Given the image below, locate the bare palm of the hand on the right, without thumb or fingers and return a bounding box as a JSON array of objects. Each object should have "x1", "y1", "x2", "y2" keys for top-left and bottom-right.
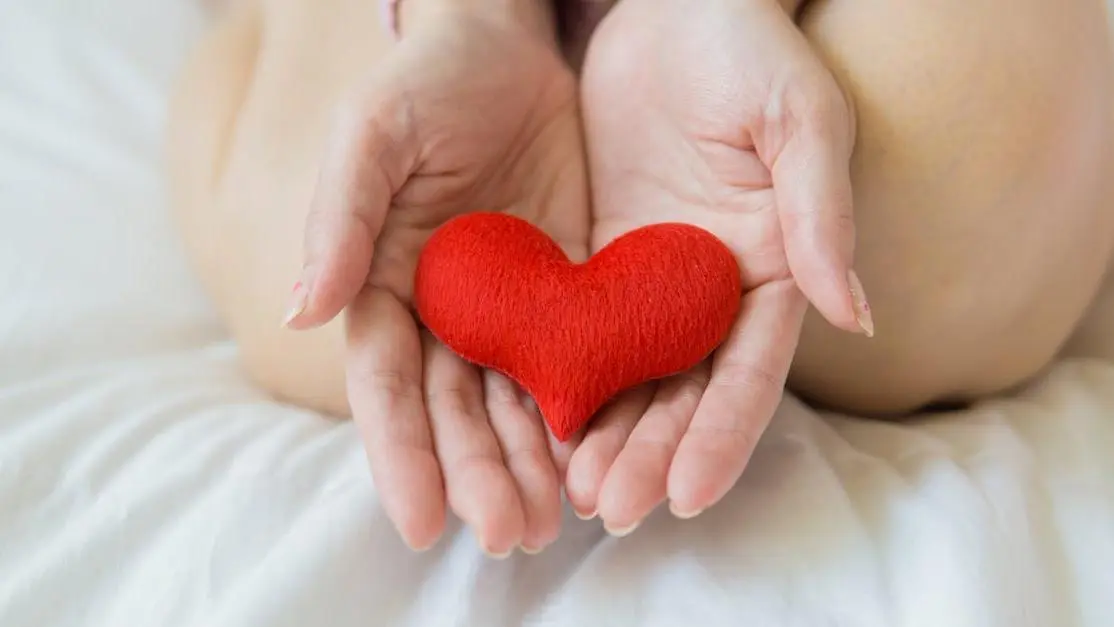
[{"x1": 584, "y1": 0, "x2": 789, "y2": 281}]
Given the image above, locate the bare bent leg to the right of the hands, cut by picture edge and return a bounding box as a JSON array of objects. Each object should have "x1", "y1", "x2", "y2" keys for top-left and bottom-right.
[{"x1": 790, "y1": 0, "x2": 1114, "y2": 412}]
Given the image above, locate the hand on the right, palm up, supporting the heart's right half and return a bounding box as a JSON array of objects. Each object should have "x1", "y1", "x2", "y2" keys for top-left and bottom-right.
[{"x1": 566, "y1": 0, "x2": 872, "y2": 535}]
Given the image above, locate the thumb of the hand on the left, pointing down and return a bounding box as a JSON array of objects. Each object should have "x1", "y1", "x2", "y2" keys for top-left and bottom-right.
[{"x1": 285, "y1": 79, "x2": 418, "y2": 329}]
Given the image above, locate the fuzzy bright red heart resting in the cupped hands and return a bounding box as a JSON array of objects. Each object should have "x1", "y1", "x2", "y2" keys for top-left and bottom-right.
[{"x1": 414, "y1": 213, "x2": 742, "y2": 441}]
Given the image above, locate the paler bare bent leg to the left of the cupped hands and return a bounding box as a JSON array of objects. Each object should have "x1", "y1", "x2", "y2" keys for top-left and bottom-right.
[{"x1": 169, "y1": 0, "x2": 390, "y2": 414}]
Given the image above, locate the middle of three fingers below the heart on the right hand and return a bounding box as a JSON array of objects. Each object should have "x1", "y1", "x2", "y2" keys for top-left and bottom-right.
[{"x1": 598, "y1": 362, "x2": 709, "y2": 537}]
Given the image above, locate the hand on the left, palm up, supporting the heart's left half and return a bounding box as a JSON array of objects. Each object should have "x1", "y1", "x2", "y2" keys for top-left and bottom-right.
[{"x1": 287, "y1": 0, "x2": 588, "y2": 556}]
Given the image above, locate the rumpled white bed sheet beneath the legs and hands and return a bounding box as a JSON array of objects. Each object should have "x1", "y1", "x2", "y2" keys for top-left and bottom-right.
[{"x1": 0, "y1": 0, "x2": 1114, "y2": 627}]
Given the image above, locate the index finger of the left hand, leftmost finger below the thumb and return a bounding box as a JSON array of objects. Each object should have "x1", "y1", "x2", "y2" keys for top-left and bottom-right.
[{"x1": 346, "y1": 287, "x2": 444, "y2": 550}]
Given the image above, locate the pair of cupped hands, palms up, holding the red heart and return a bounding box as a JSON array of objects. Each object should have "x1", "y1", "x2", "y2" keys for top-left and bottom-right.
[{"x1": 280, "y1": 0, "x2": 872, "y2": 556}]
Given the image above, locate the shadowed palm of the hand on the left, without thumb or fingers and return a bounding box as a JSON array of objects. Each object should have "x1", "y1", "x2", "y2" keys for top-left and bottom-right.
[{"x1": 369, "y1": 18, "x2": 587, "y2": 301}]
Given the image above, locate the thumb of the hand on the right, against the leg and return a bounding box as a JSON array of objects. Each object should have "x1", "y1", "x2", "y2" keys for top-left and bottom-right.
[{"x1": 771, "y1": 87, "x2": 873, "y2": 336}]
